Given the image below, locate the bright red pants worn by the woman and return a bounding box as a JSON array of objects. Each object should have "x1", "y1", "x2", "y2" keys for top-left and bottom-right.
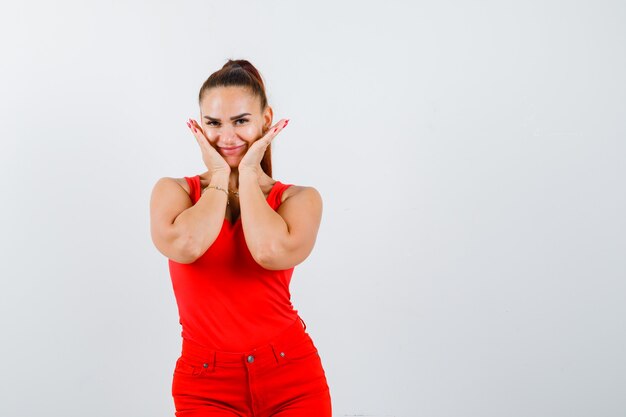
[{"x1": 172, "y1": 317, "x2": 332, "y2": 417}]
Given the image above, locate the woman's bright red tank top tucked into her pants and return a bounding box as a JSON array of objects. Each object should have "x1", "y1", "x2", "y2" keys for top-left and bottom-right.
[{"x1": 169, "y1": 175, "x2": 298, "y2": 352}]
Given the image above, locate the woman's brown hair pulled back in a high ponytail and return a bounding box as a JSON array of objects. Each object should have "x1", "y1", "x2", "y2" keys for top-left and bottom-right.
[{"x1": 198, "y1": 59, "x2": 272, "y2": 177}]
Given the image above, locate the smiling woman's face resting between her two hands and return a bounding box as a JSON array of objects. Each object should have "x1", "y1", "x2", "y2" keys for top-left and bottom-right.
[{"x1": 200, "y1": 86, "x2": 272, "y2": 168}]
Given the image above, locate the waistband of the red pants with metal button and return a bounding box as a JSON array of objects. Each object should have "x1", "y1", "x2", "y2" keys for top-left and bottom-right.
[{"x1": 181, "y1": 316, "x2": 313, "y2": 371}]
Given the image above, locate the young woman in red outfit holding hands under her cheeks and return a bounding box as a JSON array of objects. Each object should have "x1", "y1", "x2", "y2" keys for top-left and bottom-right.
[{"x1": 150, "y1": 60, "x2": 332, "y2": 417}]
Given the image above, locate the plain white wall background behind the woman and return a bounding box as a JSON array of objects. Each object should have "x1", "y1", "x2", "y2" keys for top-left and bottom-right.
[{"x1": 0, "y1": 0, "x2": 626, "y2": 417}]
